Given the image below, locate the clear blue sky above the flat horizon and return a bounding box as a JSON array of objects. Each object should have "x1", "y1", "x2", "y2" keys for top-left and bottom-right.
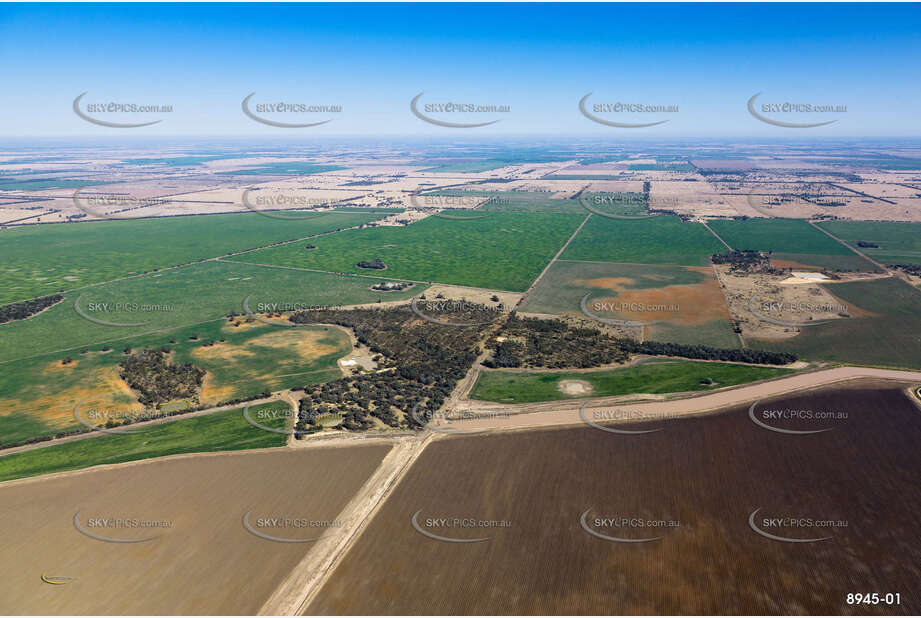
[{"x1": 0, "y1": 4, "x2": 921, "y2": 139}]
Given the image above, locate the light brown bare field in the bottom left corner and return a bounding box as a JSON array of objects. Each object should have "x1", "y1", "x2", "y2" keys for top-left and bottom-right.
[{"x1": 0, "y1": 443, "x2": 391, "y2": 615}]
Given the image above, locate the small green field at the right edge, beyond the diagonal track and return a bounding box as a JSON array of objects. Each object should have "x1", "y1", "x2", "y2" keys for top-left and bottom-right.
[{"x1": 819, "y1": 221, "x2": 921, "y2": 264}]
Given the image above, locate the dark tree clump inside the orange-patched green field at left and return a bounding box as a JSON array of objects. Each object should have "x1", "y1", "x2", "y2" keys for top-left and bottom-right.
[{"x1": 118, "y1": 348, "x2": 205, "y2": 406}]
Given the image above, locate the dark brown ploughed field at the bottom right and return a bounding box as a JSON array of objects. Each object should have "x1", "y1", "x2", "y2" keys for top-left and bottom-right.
[{"x1": 306, "y1": 383, "x2": 921, "y2": 615}]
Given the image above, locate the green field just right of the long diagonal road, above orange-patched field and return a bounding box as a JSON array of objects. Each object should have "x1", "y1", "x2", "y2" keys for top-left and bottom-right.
[{"x1": 561, "y1": 215, "x2": 725, "y2": 266}]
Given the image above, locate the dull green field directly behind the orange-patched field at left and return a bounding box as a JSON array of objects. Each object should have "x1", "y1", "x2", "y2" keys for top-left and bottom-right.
[{"x1": 0, "y1": 258, "x2": 426, "y2": 364}]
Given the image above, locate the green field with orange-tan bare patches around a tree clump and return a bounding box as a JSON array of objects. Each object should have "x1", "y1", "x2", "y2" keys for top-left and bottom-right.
[{"x1": 0, "y1": 319, "x2": 351, "y2": 442}]
